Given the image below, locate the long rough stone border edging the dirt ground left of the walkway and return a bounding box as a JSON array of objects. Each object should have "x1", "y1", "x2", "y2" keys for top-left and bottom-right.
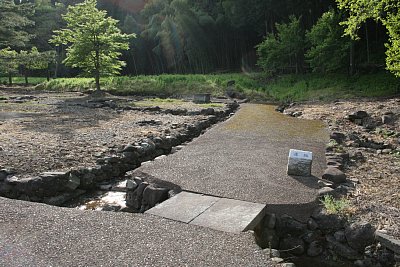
[{"x1": 0, "y1": 101, "x2": 239, "y2": 206}]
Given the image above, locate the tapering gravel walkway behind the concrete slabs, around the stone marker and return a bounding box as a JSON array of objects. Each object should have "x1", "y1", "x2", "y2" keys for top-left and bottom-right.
[{"x1": 137, "y1": 104, "x2": 329, "y2": 220}]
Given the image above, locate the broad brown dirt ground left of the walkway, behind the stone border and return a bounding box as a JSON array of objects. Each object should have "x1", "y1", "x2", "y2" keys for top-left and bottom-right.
[{"x1": 0, "y1": 88, "x2": 225, "y2": 176}]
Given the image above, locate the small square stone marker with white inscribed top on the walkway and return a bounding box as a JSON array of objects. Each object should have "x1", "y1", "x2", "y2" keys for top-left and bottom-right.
[{"x1": 287, "y1": 149, "x2": 312, "y2": 176}]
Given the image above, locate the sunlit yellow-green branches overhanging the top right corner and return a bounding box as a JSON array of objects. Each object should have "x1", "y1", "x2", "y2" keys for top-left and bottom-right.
[{"x1": 336, "y1": 0, "x2": 400, "y2": 77}]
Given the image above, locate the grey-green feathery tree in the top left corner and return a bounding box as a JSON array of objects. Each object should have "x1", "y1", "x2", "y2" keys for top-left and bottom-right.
[{"x1": 0, "y1": 0, "x2": 34, "y2": 48}]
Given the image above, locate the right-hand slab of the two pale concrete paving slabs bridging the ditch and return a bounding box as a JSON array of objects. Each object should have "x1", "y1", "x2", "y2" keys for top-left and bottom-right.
[{"x1": 190, "y1": 198, "x2": 265, "y2": 233}]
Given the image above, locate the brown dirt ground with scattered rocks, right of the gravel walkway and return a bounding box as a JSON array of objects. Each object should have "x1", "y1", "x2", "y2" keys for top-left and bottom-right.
[{"x1": 285, "y1": 98, "x2": 400, "y2": 239}]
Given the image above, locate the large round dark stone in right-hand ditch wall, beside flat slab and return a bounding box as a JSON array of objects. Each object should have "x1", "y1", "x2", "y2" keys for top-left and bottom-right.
[{"x1": 345, "y1": 222, "x2": 375, "y2": 252}]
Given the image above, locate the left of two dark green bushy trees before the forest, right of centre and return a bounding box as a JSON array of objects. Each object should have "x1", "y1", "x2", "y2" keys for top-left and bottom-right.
[{"x1": 257, "y1": 16, "x2": 305, "y2": 73}]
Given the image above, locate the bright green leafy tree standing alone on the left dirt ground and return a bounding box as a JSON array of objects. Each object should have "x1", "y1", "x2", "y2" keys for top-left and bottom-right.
[{"x1": 50, "y1": 0, "x2": 135, "y2": 91}]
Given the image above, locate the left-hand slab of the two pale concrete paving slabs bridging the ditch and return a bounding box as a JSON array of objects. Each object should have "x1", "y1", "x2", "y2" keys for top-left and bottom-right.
[{"x1": 145, "y1": 192, "x2": 220, "y2": 223}]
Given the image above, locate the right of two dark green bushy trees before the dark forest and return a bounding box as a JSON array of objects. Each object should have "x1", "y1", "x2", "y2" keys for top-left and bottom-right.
[{"x1": 306, "y1": 10, "x2": 351, "y2": 73}]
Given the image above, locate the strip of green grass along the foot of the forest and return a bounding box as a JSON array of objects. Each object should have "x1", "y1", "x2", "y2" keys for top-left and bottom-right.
[{"x1": 0, "y1": 72, "x2": 400, "y2": 102}]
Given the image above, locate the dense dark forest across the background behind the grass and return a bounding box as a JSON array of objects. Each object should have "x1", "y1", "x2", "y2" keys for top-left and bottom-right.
[{"x1": 0, "y1": 0, "x2": 397, "y2": 77}]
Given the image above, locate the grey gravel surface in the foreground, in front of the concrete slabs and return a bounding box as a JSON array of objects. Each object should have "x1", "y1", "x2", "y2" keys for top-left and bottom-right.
[{"x1": 0, "y1": 198, "x2": 273, "y2": 267}]
